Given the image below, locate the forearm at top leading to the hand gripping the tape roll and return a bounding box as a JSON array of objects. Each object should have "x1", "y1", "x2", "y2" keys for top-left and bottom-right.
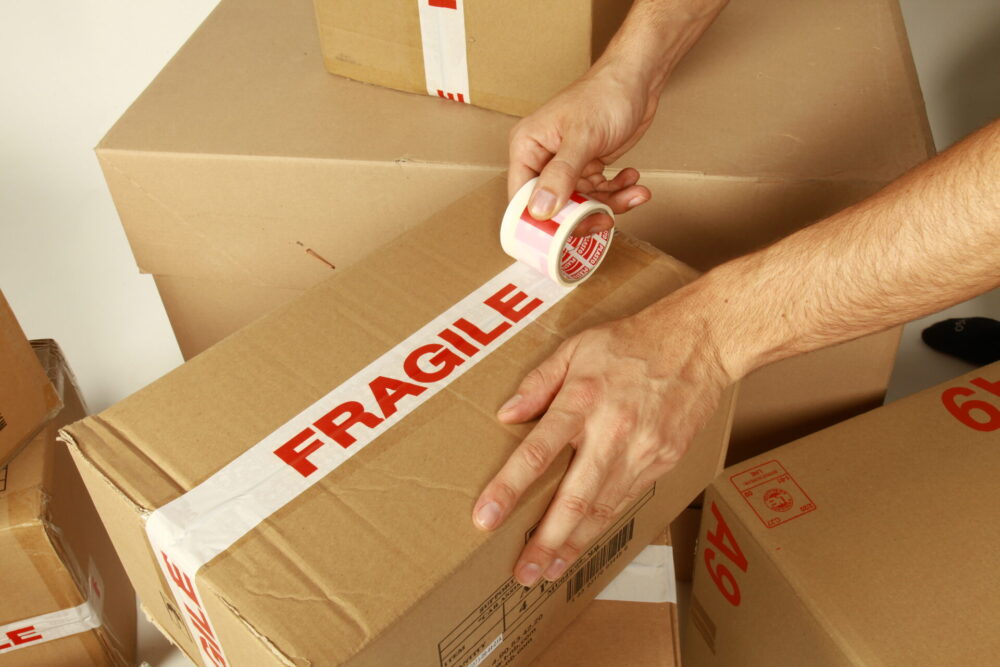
[{"x1": 594, "y1": 0, "x2": 728, "y2": 98}]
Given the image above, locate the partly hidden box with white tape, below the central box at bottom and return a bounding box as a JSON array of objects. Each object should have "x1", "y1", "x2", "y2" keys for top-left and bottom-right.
[{"x1": 531, "y1": 533, "x2": 681, "y2": 667}]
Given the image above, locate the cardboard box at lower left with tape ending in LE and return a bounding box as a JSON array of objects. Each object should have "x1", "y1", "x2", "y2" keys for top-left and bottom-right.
[{"x1": 0, "y1": 340, "x2": 135, "y2": 667}]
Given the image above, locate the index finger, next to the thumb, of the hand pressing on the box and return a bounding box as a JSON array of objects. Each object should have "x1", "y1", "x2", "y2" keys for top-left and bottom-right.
[{"x1": 472, "y1": 408, "x2": 583, "y2": 530}]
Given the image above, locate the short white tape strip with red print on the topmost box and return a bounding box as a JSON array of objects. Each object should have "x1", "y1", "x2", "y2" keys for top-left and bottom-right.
[{"x1": 417, "y1": 0, "x2": 471, "y2": 104}]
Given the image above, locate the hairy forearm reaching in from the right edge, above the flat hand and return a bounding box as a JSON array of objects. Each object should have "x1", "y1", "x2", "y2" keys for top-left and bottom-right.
[{"x1": 688, "y1": 121, "x2": 1000, "y2": 378}]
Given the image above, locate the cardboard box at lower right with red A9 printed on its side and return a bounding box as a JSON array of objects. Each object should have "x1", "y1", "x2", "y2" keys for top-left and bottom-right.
[{"x1": 684, "y1": 364, "x2": 1000, "y2": 667}]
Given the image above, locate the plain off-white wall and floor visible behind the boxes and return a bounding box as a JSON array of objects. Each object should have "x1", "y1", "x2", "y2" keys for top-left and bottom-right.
[{"x1": 0, "y1": 0, "x2": 1000, "y2": 665}]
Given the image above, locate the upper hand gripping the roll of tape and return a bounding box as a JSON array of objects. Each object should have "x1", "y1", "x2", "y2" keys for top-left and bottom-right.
[{"x1": 507, "y1": 64, "x2": 658, "y2": 235}]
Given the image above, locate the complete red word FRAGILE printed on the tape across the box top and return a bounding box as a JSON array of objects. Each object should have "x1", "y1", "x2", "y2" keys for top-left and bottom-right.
[{"x1": 276, "y1": 284, "x2": 542, "y2": 474}]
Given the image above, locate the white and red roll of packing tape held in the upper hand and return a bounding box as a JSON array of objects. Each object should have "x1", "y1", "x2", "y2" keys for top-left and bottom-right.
[{"x1": 500, "y1": 178, "x2": 615, "y2": 287}]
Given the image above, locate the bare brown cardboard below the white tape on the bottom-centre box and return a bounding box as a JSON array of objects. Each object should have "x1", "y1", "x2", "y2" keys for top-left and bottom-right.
[{"x1": 531, "y1": 533, "x2": 681, "y2": 667}]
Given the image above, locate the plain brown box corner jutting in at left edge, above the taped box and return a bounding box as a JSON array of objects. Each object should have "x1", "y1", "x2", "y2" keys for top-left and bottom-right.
[{"x1": 0, "y1": 292, "x2": 62, "y2": 466}]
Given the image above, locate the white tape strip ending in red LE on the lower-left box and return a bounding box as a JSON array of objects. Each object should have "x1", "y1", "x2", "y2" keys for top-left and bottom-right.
[{"x1": 0, "y1": 563, "x2": 104, "y2": 656}]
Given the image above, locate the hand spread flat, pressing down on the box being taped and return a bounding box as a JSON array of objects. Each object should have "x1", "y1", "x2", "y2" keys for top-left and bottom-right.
[{"x1": 473, "y1": 290, "x2": 732, "y2": 586}]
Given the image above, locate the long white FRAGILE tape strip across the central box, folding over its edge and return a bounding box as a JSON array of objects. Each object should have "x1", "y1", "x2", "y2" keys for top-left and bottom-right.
[{"x1": 146, "y1": 262, "x2": 572, "y2": 666}]
